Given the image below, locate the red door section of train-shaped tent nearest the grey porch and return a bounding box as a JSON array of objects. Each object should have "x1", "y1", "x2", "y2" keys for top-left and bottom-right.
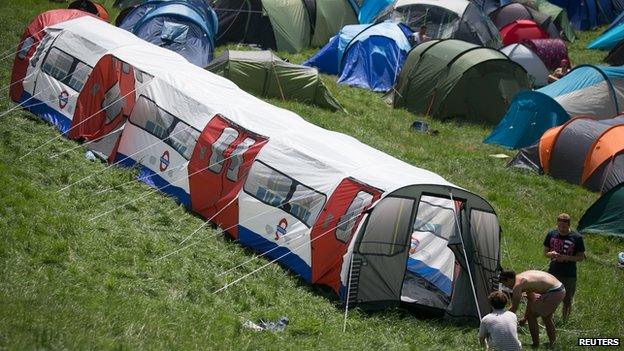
[{"x1": 310, "y1": 178, "x2": 381, "y2": 291}]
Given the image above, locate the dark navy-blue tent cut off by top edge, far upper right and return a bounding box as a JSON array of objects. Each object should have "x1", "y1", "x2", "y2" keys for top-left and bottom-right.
[{"x1": 549, "y1": 0, "x2": 621, "y2": 30}]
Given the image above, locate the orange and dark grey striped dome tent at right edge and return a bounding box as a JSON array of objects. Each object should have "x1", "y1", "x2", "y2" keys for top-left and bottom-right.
[{"x1": 510, "y1": 116, "x2": 624, "y2": 192}]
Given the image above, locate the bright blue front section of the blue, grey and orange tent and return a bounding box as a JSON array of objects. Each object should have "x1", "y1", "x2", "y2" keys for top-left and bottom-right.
[{"x1": 483, "y1": 91, "x2": 570, "y2": 149}]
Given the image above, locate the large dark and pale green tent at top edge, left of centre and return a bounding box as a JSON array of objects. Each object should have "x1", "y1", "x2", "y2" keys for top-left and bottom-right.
[{"x1": 213, "y1": 0, "x2": 357, "y2": 53}]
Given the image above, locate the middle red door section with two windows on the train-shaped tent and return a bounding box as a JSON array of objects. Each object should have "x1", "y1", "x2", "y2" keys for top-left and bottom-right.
[{"x1": 189, "y1": 115, "x2": 267, "y2": 237}]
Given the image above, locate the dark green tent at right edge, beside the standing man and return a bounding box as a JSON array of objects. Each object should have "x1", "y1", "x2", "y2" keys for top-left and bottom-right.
[{"x1": 578, "y1": 183, "x2": 624, "y2": 237}]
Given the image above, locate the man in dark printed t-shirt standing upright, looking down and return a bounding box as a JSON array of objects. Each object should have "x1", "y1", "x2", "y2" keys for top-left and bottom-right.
[{"x1": 544, "y1": 213, "x2": 585, "y2": 321}]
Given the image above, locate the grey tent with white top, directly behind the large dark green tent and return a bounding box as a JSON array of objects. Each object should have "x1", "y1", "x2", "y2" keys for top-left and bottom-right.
[{"x1": 378, "y1": 0, "x2": 502, "y2": 49}]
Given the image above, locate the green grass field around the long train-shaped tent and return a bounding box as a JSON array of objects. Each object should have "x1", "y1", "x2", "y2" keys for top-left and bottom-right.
[{"x1": 0, "y1": 0, "x2": 624, "y2": 350}]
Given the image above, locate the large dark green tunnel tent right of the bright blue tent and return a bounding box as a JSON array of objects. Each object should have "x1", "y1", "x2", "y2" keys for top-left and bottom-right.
[{"x1": 390, "y1": 39, "x2": 530, "y2": 124}]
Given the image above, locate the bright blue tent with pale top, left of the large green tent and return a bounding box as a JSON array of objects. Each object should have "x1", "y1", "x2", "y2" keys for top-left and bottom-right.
[{"x1": 303, "y1": 22, "x2": 412, "y2": 91}]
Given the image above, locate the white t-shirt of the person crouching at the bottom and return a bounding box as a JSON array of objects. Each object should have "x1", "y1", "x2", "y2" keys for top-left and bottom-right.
[{"x1": 479, "y1": 310, "x2": 522, "y2": 351}]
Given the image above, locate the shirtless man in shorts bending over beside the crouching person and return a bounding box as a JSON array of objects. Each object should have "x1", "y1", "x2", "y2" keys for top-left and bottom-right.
[{"x1": 499, "y1": 271, "x2": 565, "y2": 347}]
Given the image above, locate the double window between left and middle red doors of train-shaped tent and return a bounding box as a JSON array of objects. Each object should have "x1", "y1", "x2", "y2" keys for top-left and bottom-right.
[{"x1": 130, "y1": 95, "x2": 200, "y2": 160}]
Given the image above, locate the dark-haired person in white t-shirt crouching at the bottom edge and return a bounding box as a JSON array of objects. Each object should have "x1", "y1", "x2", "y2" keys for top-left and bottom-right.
[{"x1": 479, "y1": 291, "x2": 522, "y2": 351}]
